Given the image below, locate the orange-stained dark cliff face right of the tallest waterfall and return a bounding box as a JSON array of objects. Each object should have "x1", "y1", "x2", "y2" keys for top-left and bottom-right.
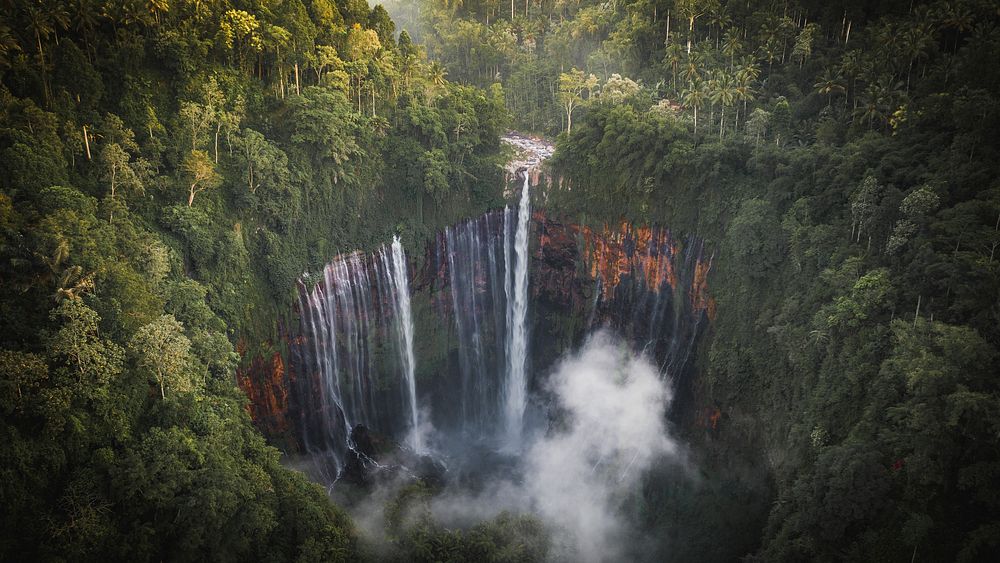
[{"x1": 531, "y1": 213, "x2": 715, "y2": 391}]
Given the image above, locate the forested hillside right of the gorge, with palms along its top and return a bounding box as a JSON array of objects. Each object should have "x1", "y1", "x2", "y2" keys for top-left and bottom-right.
[{"x1": 410, "y1": 0, "x2": 1000, "y2": 561}]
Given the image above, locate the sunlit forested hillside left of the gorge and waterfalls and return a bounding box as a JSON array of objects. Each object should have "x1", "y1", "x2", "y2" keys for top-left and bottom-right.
[{"x1": 0, "y1": 0, "x2": 506, "y2": 561}]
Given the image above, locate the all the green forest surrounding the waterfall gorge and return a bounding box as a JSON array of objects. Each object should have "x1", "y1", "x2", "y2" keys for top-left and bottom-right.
[{"x1": 0, "y1": 0, "x2": 1000, "y2": 561}]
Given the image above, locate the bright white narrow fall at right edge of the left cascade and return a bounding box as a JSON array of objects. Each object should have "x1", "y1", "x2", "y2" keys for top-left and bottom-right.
[{"x1": 382, "y1": 236, "x2": 423, "y2": 452}]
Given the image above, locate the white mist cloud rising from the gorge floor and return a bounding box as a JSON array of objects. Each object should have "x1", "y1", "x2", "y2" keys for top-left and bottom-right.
[{"x1": 414, "y1": 331, "x2": 678, "y2": 561}]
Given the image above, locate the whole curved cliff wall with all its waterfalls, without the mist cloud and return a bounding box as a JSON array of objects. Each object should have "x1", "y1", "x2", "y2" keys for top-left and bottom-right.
[{"x1": 278, "y1": 173, "x2": 714, "y2": 483}]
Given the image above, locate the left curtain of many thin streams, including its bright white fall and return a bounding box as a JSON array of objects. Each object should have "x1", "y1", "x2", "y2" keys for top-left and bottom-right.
[{"x1": 299, "y1": 237, "x2": 423, "y2": 481}]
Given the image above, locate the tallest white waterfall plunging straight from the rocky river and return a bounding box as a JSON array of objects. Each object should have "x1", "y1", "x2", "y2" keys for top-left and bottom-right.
[{"x1": 504, "y1": 171, "x2": 531, "y2": 446}]
